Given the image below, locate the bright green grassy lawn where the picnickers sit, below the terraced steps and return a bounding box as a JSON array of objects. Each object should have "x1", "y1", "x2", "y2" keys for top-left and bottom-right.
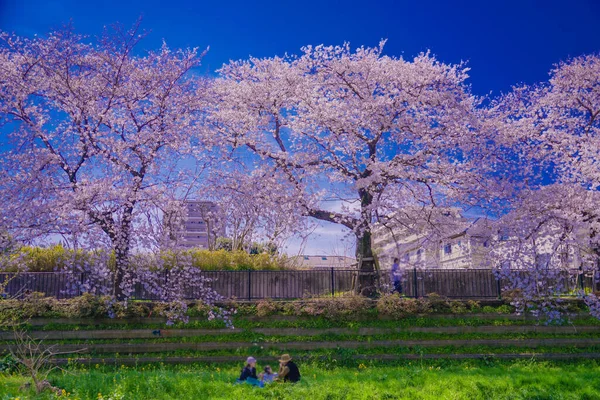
[{"x1": 0, "y1": 360, "x2": 600, "y2": 400}]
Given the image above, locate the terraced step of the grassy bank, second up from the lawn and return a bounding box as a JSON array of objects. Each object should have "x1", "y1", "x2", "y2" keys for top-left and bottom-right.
[{"x1": 0, "y1": 338, "x2": 600, "y2": 354}]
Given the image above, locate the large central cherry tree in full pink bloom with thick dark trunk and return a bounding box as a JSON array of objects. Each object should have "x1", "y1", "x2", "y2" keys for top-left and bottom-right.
[{"x1": 210, "y1": 42, "x2": 478, "y2": 292}]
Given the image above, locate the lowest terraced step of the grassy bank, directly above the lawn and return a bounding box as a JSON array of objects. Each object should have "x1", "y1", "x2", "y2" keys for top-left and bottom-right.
[{"x1": 51, "y1": 353, "x2": 600, "y2": 365}]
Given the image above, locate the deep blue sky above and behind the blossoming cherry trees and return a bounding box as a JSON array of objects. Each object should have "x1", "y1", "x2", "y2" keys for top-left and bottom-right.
[{"x1": 0, "y1": 0, "x2": 600, "y2": 254}]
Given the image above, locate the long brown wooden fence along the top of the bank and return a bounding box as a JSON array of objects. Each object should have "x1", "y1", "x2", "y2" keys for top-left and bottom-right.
[{"x1": 0, "y1": 268, "x2": 597, "y2": 300}]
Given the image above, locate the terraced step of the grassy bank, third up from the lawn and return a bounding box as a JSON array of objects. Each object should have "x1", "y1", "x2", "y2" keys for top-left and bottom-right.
[{"x1": 0, "y1": 325, "x2": 600, "y2": 340}]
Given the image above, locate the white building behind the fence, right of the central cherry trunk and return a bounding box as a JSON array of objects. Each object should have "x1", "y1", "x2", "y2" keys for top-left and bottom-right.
[{"x1": 373, "y1": 210, "x2": 590, "y2": 269}]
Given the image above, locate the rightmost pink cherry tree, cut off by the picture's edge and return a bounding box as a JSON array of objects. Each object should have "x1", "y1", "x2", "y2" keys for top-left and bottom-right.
[{"x1": 487, "y1": 55, "x2": 600, "y2": 316}]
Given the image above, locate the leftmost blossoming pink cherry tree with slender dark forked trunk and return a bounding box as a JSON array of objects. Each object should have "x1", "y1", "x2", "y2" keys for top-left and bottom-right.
[{"x1": 0, "y1": 26, "x2": 209, "y2": 300}]
